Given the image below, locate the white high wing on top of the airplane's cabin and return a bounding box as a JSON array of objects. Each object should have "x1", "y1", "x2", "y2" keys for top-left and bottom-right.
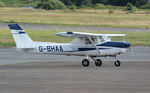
[{"x1": 55, "y1": 32, "x2": 126, "y2": 38}]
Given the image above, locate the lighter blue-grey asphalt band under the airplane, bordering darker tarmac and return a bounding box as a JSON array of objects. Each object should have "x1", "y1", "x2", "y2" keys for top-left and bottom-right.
[{"x1": 0, "y1": 46, "x2": 150, "y2": 65}]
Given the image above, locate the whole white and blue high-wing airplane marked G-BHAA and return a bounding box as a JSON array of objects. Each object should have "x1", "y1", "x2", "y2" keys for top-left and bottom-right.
[{"x1": 8, "y1": 23, "x2": 131, "y2": 67}]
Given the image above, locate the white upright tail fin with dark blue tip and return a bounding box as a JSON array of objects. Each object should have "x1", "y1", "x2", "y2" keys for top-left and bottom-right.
[{"x1": 8, "y1": 24, "x2": 33, "y2": 48}]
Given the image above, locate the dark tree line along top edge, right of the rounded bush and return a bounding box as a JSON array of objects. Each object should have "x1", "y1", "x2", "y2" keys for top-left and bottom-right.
[{"x1": 61, "y1": 0, "x2": 150, "y2": 9}]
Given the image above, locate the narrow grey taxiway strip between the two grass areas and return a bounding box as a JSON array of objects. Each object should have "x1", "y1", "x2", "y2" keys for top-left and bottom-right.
[{"x1": 0, "y1": 23, "x2": 150, "y2": 32}]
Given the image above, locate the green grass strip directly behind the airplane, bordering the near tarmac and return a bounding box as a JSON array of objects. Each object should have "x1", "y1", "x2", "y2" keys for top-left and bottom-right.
[{"x1": 0, "y1": 29, "x2": 150, "y2": 47}]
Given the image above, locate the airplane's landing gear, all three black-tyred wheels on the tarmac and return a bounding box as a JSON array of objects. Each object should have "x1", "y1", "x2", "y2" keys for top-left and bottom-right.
[{"x1": 82, "y1": 57, "x2": 121, "y2": 67}]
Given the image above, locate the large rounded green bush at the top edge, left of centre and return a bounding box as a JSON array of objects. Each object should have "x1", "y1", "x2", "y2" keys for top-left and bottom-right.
[{"x1": 37, "y1": 0, "x2": 66, "y2": 10}]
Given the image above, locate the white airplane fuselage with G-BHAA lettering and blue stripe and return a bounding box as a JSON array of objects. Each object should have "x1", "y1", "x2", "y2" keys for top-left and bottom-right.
[{"x1": 24, "y1": 42, "x2": 127, "y2": 56}]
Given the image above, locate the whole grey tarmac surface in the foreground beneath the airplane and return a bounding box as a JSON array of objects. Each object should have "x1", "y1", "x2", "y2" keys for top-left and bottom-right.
[{"x1": 0, "y1": 46, "x2": 150, "y2": 93}]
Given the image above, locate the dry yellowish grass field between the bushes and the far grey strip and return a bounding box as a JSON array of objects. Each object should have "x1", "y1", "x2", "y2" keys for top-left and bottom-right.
[{"x1": 0, "y1": 8, "x2": 150, "y2": 28}]
